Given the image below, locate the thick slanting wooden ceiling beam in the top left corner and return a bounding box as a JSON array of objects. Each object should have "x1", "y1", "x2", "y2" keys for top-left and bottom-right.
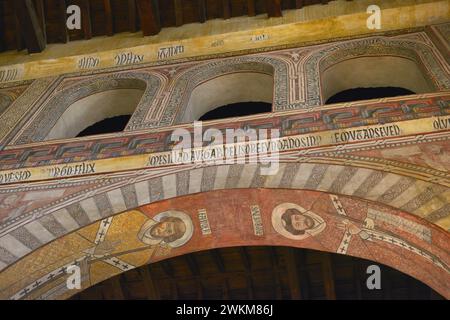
[{"x1": 14, "y1": 0, "x2": 46, "y2": 53}]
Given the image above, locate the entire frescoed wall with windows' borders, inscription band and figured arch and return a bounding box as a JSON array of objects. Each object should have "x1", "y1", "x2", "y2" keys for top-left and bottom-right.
[{"x1": 0, "y1": 24, "x2": 450, "y2": 299}]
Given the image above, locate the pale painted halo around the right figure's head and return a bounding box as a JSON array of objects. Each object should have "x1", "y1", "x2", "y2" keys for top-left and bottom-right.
[{"x1": 272, "y1": 203, "x2": 326, "y2": 240}]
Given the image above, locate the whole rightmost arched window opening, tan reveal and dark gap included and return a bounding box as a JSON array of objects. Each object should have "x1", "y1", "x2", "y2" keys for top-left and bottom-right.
[{"x1": 321, "y1": 56, "x2": 432, "y2": 103}]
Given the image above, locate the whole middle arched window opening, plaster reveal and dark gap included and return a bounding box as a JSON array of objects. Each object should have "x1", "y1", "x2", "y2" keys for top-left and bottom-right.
[{"x1": 182, "y1": 72, "x2": 274, "y2": 122}]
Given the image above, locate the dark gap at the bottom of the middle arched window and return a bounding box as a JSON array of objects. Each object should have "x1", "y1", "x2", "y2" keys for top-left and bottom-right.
[{"x1": 199, "y1": 102, "x2": 272, "y2": 121}]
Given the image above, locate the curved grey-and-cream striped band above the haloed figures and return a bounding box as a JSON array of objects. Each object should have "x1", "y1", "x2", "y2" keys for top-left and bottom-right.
[{"x1": 0, "y1": 162, "x2": 450, "y2": 269}]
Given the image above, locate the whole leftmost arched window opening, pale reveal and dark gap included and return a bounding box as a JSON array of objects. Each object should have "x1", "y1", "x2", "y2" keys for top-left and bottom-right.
[{"x1": 46, "y1": 88, "x2": 144, "y2": 140}]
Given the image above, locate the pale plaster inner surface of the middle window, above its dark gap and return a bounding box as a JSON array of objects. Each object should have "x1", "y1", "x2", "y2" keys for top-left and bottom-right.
[{"x1": 182, "y1": 72, "x2": 274, "y2": 122}]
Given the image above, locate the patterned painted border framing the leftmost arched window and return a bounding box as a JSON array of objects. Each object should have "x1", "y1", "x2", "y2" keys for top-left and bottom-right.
[{"x1": 14, "y1": 72, "x2": 161, "y2": 144}]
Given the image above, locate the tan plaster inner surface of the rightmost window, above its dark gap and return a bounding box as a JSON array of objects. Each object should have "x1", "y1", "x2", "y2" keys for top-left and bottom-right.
[{"x1": 322, "y1": 56, "x2": 433, "y2": 101}]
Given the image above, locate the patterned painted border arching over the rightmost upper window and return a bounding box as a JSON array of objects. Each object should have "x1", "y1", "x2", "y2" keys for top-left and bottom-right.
[{"x1": 304, "y1": 37, "x2": 450, "y2": 106}]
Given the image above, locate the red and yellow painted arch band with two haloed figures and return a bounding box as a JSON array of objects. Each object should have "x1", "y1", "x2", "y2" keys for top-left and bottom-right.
[{"x1": 0, "y1": 189, "x2": 450, "y2": 299}]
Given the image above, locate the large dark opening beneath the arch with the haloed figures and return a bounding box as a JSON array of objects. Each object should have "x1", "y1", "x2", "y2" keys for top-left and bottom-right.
[{"x1": 72, "y1": 246, "x2": 443, "y2": 300}]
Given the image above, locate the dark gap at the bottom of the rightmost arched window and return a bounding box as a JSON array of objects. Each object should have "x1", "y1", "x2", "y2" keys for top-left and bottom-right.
[{"x1": 325, "y1": 87, "x2": 414, "y2": 104}]
